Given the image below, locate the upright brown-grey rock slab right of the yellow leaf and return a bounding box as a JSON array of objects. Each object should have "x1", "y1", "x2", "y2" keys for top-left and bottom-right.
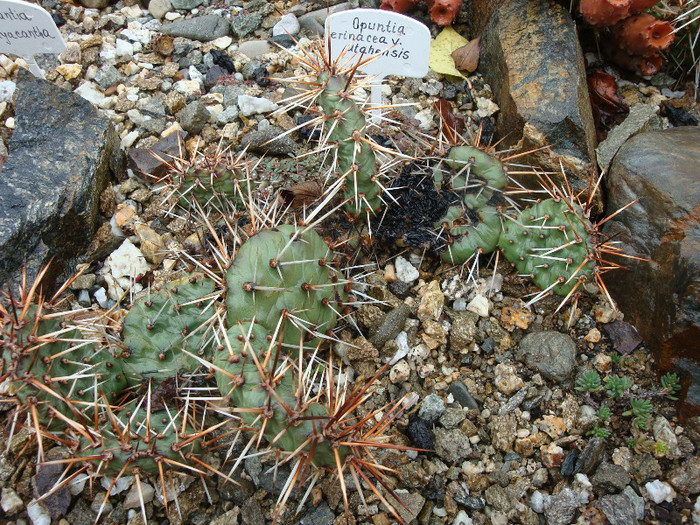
[{"x1": 479, "y1": 0, "x2": 596, "y2": 199}]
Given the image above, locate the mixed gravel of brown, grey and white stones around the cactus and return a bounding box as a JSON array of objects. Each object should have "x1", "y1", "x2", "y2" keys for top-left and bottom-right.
[{"x1": 0, "y1": 0, "x2": 700, "y2": 525}]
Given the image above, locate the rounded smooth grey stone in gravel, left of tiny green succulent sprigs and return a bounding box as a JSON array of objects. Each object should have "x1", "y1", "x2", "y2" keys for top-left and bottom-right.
[{"x1": 517, "y1": 331, "x2": 576, "y2": 383}]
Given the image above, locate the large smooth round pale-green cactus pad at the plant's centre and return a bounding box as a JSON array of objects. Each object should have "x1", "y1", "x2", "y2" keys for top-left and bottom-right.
[{"x1": 226, "y1": 226, "x2": 345, "y2": 355}]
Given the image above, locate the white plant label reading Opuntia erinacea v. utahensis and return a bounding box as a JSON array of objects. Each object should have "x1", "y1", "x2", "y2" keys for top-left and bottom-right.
[{"x1": 326, "y1": 9, "x2": 430, "y2": 120}]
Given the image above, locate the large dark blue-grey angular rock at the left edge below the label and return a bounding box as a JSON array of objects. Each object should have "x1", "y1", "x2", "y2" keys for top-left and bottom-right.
[{"x1": 0, "y1": 70, "x2": 119, "y2": 283}]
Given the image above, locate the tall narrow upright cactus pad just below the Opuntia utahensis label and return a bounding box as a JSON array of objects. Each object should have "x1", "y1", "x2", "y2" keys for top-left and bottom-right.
[{"x1": 318, "y1": 73, "x2": 383, "y2": 218}]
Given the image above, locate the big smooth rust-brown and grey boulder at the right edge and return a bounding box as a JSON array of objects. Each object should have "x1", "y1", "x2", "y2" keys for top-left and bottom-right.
[{"x1": 605, "y1": 127, "x2": 700, "y2": 415}]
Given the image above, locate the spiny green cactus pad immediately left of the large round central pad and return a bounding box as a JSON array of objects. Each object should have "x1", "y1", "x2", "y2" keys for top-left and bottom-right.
[{"x1": 122, "y1": 275, "x2": 215, "y2": 386}]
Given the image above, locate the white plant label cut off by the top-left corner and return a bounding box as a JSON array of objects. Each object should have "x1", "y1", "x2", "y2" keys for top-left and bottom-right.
[{"x1": 0, "y1": 0, "x2": 66, "y2": 78}]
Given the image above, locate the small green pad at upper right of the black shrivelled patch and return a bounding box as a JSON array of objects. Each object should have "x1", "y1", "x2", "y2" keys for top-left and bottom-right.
[{"x1": 447, "y1": 146, "x2": 508, "y2": 210}]
